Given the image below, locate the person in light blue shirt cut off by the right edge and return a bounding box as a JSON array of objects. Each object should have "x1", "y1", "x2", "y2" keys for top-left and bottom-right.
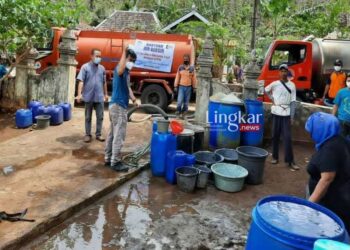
[{"x1": 333, "y1": 73, "x2": 350, "y2": 137}]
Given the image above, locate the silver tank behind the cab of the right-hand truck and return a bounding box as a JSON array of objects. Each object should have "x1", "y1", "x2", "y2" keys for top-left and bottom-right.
[{"x1": 312, "y1": 38, "x2": 350, "y2": 95}]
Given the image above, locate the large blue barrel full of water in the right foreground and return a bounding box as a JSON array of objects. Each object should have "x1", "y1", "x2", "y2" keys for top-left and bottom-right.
[{"x1": 246, "y1": 195, "x2": 346, "y2": 250}]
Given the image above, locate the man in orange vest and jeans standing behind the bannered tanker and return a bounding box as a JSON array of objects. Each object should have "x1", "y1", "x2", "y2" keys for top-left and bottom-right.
[{"x1": 174, "y1": 55, "x2": 197, "y2": 118}]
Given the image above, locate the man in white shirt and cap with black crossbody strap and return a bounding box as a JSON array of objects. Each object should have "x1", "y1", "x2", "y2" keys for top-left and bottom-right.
[{"x1": 265, "y1": 64, "x2": 299, "y2": 171}]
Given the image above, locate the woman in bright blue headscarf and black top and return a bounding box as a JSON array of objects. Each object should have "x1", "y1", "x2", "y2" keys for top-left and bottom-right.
[{"x1": 305, "y1": 112, "x2": 350, "y2": 231}]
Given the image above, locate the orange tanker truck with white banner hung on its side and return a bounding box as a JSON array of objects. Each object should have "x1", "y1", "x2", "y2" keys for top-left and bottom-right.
[{"x1": 36, "y1": 28, "x2": 195, "y2": 109}]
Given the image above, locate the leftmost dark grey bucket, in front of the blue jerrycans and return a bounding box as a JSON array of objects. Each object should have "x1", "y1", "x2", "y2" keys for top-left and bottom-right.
[{"x1": 176, "y1": 167, "x2": 199, "y2": 193}]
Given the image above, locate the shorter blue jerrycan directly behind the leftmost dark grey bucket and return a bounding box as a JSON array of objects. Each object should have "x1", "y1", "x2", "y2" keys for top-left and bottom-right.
[{"x1": 165, "y1": 150, "x2": 196, "y2": 184}]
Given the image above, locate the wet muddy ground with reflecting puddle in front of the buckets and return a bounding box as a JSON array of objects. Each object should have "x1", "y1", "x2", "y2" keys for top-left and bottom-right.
[{"x1": 29, "y1": 171, "x2": 250, "y2": 250}]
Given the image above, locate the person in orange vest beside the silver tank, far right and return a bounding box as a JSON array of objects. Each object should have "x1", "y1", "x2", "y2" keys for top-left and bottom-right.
[{"x1": 322, "y1": 59, "x2": 346, "y2": 106}]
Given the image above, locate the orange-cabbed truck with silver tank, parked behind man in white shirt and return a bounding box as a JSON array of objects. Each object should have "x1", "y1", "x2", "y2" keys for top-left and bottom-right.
[{"x1": 258, "y1": 38, "x2": 350, "y2": 102}]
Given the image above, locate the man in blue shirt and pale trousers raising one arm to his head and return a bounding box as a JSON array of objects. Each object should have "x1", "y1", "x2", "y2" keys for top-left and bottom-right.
[{"x1": 105, "y1": 46, "x2": 138, "y2": 171}]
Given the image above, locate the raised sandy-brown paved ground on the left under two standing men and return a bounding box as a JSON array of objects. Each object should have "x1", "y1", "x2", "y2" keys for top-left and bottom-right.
[{"x1": 0, "y1": 109, "x2": 151, "y2": 249}]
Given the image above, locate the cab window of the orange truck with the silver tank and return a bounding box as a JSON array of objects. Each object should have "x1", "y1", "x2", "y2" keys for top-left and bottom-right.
[{"x1": 270, "y1": 44, "x2": 306, "y2": 70}]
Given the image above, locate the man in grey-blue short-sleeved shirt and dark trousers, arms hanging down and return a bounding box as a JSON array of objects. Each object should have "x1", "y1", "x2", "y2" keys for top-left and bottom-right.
[{"x1": 75, "y1": 49, "x2": 108, "y2": 143}]
